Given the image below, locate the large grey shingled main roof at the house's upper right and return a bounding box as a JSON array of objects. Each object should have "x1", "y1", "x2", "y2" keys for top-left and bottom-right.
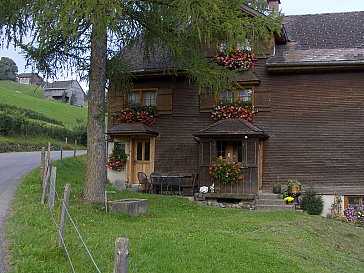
[{"x1": 267, "y1": 11, "x2": 364, "y2": 69}]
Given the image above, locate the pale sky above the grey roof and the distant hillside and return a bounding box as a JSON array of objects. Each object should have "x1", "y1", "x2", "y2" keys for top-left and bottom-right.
[{"x1": 0, "y1": 0, "x2": 364, "y2": 91}]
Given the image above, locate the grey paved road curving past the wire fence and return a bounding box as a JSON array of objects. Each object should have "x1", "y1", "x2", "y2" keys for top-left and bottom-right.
[{"x1": 0, "y1": 151, "x2": 86, "y2": 273}]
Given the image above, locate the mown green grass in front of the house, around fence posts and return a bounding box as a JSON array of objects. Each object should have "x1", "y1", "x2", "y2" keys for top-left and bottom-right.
[{"x1": 6, "y1": 156, "x2": 364, "y2": 273}]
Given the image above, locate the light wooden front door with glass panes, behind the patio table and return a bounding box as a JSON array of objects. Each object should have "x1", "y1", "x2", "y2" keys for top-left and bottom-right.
[{"x1": 132, "y1": 138, "x2": 154, "y2": 183}]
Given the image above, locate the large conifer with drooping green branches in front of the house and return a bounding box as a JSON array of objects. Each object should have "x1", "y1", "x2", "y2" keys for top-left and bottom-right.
[{"x1": 0, "y1": 0, "x2": 281, "y2": 202}]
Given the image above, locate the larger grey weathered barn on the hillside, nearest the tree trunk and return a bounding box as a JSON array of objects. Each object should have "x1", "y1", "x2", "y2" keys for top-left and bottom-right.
[{"x1": 44, "y1": 80, "x2": 85, "y2": 106}]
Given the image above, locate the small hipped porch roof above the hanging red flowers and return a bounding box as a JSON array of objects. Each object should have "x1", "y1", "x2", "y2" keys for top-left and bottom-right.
[{"x1": 194, "y1": 118, "x2": 268, "y2": 138}]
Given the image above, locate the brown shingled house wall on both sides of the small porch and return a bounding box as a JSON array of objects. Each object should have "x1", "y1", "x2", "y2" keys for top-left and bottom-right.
[{"x1": 110, "y1": 59, "x2": 364, "y2": 195}]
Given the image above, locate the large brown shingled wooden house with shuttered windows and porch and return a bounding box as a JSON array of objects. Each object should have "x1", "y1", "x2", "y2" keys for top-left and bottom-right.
[{"x1": 108, "y1": 1, "x2": 364, "y2": 214}]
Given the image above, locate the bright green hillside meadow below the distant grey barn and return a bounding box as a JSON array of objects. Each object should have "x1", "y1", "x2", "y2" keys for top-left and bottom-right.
[{"x1": 0, "y1": 80, "x2": 87, "y2": 128}]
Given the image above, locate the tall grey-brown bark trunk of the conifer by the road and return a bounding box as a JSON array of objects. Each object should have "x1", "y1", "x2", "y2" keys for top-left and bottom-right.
[{"x1": 84, "y1": 25, "x2": 107, "y2": 202}]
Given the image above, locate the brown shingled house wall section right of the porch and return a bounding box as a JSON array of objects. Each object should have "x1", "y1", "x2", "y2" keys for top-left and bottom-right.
[{"x1": 255, "y1": 63, "x2": 364, "y2": 194}]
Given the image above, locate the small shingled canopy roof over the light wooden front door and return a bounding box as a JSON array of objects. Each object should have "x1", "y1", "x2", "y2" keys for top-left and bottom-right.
[{"x1": 107, "y1": 122, "x2": 159, "y2": 136}]
